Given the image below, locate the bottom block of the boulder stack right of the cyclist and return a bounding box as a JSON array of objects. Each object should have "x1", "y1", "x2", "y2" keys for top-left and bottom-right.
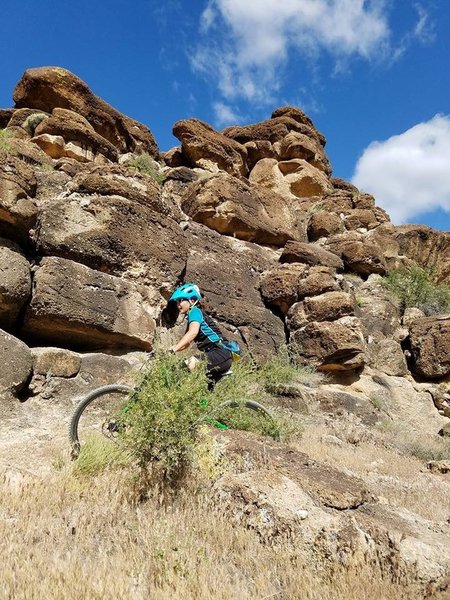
[{"x1": 291, "y1": 317, "x2": 365, "y2": 371}]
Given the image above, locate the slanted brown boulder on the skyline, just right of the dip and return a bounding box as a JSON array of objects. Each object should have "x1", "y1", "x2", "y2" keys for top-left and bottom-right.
[{"x1": 173, "y1": 119, "x2": 247, "y2": 175}]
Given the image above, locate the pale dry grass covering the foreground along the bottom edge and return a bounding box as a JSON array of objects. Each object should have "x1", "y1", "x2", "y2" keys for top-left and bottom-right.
[{"x1": 0, "y1": 467, "x2": 421, "y2": 600}]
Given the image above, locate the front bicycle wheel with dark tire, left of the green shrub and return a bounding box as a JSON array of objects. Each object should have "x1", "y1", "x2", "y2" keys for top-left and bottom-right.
[{"x1": 69, "y1": 384, "x2": 135, "y2": 458}]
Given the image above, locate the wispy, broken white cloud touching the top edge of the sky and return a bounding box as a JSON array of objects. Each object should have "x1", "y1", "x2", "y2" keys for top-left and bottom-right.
[{"x1": 192, "y1": 0, "x2": 390, "y2": 102}]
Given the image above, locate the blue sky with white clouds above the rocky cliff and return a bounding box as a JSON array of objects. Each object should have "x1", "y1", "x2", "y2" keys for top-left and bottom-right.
[{"x1": 0, "y1": 0, "x2": 450, "y2": 230}]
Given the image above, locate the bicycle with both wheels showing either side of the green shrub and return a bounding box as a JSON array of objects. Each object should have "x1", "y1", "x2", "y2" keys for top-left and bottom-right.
[{"x1": 69, "y1": 384, "x2": 279, "y2": 458}]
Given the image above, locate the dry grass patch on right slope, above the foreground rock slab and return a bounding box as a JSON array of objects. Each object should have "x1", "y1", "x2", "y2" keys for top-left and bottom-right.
[{"x1": 295, "y1": 422, "x2": 450, "y2": 523}]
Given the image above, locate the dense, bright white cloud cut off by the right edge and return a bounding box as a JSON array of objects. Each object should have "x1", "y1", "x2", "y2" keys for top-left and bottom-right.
[{"x1": 352, "y1": 115, "x2": 450, "y2": 224}]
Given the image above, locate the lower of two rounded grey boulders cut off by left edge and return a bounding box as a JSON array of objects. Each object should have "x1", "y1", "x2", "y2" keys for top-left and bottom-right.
[{"x1": 0, "y1": 329, "x2": 32, "y2": 396}]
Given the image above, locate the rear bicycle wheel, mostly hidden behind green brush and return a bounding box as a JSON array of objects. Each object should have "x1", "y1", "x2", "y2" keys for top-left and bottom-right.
[{"x1": 214, "y1": 399, "x2": 281, "y2": 440}]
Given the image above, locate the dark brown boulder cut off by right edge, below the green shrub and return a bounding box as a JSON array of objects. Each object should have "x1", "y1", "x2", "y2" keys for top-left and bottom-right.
[{"x1": 409, "y1": 315, "x2": 450, "y2": 379}]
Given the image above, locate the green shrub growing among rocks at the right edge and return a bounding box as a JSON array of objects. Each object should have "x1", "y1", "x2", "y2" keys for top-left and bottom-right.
[{"x1": 383, "y1": 266, "x2": 450, "y2": 315}]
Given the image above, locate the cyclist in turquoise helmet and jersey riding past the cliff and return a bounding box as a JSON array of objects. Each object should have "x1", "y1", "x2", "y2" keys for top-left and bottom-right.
[{"x1": 169, "y1": 283, "x2": 232, "y2": 387}]
